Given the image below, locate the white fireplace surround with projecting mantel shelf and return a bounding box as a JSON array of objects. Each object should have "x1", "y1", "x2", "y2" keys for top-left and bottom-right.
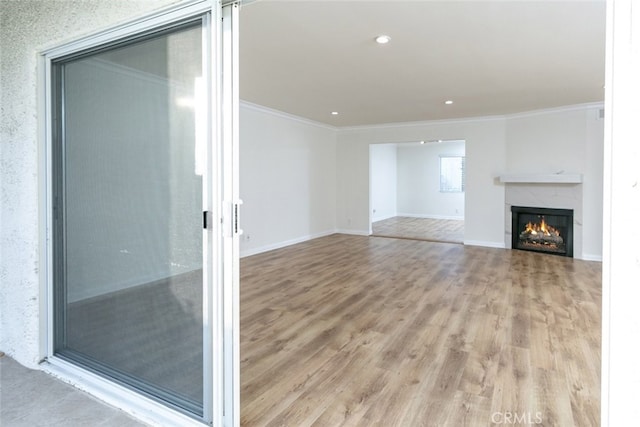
[{"x1": 498, "y1": 173, "x2": 583, "y2": 259}]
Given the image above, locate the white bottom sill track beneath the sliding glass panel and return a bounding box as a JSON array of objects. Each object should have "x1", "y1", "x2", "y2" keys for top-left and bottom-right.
[{"x1": 40, "y1": 357, "x2": 207, "y2": 427}]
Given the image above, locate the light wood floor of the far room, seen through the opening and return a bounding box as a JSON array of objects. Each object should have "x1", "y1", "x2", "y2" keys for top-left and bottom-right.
[{"x1": 372, "y1": 216, "x2": 464, "y2": 243}]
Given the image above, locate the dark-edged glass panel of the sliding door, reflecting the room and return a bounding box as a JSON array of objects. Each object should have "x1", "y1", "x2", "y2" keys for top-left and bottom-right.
[{"x1": 51, "y1": 17, "x2": 208, "y2": 417}]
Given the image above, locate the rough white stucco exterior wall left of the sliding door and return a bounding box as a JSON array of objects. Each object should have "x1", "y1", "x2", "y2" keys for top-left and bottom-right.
[{"x1": 0, "y1": 0, "x2": 176, "y2": 367}]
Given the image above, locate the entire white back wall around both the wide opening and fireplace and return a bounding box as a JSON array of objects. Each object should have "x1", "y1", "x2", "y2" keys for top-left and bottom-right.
[{"x1": 336, "y1": 105, "x2": 604, "y2": 252}]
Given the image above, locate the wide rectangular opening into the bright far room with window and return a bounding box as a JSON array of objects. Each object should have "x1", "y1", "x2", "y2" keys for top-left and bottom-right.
[{"x1": 369, "y1": 140, "x2": 466, "y2": 244}]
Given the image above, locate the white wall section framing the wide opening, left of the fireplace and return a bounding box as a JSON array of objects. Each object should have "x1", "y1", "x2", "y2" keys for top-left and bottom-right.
[{"x1": 336, "y1": 118, "x2": 506, "y2": 247}]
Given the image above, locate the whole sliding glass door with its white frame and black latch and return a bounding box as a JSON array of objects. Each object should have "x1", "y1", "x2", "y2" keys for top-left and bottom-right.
[{"x1": 40, "y1": 0, "x2": 241, "y2": 426}]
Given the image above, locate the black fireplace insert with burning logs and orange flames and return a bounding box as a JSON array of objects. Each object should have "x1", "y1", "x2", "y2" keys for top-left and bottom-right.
[{"x1": 511, "y1": 206, "x2": 573, "y2": 257}]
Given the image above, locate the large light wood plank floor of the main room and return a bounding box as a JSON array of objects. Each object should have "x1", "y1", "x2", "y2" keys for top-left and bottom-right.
[{"x1": 240, "y1": 235, "x2": 601, "y2": 427}]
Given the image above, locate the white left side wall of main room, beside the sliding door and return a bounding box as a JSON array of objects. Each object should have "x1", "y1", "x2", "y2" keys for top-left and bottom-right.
[{"x1": 240, "y1": 103, "x2": 336, "y2": 256}]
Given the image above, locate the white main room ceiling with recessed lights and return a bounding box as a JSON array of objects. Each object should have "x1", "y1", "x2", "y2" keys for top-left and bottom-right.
[{"x1": 240, "y1": 0, "x2": 605, "y2": 126}]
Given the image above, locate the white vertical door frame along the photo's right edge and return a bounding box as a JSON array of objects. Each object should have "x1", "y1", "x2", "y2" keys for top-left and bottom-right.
[{"x1": 600, "y1": 0, "x2": 640, "y2": 426}]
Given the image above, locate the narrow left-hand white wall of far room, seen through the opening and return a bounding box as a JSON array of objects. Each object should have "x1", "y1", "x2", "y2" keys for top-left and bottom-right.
[{"x1": 369, "y1": 144, "x2": 398, "y2": 222}]
